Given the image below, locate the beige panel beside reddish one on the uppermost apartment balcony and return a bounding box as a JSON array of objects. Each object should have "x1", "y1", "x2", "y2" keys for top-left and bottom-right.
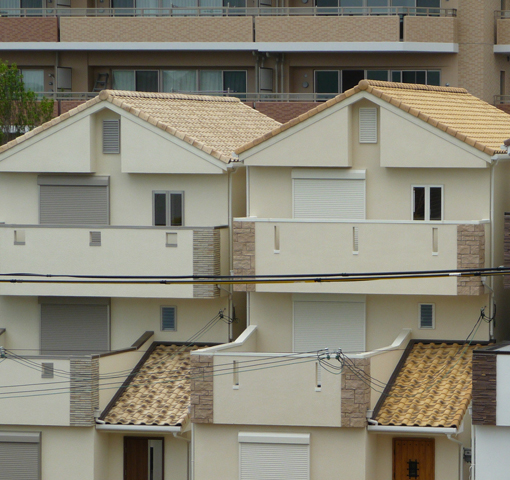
[{"x1": 60, "y1": 16, "x2": 253, "y2": 42}]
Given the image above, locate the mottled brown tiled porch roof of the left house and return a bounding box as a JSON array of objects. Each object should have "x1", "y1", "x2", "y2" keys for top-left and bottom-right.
[{"x1": 104, "y1": 345, "x2": 203, "y2": 426}]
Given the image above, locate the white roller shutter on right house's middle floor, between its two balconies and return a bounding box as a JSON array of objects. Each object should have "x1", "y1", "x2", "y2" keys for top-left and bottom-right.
[{"x1": 294, "y1": 301, "x2": 365, "y2": 353}]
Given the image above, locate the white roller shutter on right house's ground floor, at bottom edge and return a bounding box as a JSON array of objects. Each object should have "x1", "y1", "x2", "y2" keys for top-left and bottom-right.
[{"x1": 238, "y1": 432, "x2": 310, "y2": 480}]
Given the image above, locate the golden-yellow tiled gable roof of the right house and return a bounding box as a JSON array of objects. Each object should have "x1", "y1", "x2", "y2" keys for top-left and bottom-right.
[{"x1": 236, "y1": 80, "x2": 510, "y2": 155}]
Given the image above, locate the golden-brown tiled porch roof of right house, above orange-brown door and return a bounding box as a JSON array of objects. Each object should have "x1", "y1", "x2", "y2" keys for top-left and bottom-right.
[{"x1": 375, "y1": 343, "x2": 479, "y2": 427}]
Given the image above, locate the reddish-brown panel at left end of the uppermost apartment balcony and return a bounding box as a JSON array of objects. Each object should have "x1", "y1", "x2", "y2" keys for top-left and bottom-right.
[{"x1": 0, "y1": 17, "x2": 58, "y2": 42}]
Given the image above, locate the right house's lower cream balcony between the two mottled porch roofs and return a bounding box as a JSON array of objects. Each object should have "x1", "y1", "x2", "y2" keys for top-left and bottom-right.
[{"x1": 191, "y1": 325, "x2": 410, "y2": 428}]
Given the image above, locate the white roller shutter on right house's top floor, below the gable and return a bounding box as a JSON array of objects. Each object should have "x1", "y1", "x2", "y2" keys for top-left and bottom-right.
[{"x1": 294, "y1": 178, "x2": 365, "y2": 220}]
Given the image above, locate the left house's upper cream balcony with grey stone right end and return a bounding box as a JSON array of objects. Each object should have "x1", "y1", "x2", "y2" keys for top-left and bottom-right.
[{"x1": 0, "y1": 225, "x2": 228, "y2": 298}]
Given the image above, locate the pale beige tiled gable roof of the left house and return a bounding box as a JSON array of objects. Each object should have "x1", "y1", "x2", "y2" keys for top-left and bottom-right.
[{"x1": 0, "y1": 90, "x2": 281, "y2": 163}]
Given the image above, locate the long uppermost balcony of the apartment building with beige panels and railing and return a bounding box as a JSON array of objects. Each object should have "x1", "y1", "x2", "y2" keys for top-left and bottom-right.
[{"x1": 0, "y1": 6, "x2": 457, "y2": 47}]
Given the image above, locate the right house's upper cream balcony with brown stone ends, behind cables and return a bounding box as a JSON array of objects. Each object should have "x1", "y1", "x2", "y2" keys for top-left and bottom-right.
[{"x1": 233, "y1": 217, "x2": 490, "y2": 295}]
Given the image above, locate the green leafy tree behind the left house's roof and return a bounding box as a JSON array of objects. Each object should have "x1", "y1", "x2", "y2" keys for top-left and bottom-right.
[{"x1": 0, "y1": 60, "x2": 53, "y2": 145}]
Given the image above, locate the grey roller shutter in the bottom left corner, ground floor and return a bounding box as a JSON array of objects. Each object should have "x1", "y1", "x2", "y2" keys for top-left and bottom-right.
[{"x1": 0, "y1": 442, "x2": 40, "y2": 480}]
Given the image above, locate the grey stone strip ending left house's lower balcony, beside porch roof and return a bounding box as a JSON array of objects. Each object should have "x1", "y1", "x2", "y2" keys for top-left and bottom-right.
[{"x1": 70, "y1": 358, "x2": 99, "y2": 427}]
